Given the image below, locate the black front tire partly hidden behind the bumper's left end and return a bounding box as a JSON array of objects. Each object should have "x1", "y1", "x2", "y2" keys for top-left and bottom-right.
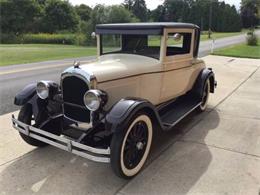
[{"x1": 18, "y1": 104, "x2": 48, "y2": 147}]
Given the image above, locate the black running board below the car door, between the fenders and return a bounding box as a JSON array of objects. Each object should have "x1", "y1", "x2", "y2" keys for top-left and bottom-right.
[{"x1": 159, "y1": 94, "x2": 201, "y2": 130}]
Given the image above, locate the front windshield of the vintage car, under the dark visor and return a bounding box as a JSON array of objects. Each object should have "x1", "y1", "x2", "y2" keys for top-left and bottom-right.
[{"x1": 100, "y1": 34, "x2": 161, "y2": 59}]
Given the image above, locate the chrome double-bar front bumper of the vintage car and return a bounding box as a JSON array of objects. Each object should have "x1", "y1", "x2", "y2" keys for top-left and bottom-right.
[{"x1": 12, "y1": 115, "x2": 110, "y2": 163}]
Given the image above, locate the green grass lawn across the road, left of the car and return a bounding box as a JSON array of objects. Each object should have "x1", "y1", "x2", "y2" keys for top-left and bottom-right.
[{"x1": 0, "y1": 44, "x2": 96, "y2": 66}]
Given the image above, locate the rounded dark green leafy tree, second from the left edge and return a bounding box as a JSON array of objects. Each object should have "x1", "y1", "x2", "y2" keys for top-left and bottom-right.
[{"x1": 42, "y1": 0, "x2": 79, "y2": 33}]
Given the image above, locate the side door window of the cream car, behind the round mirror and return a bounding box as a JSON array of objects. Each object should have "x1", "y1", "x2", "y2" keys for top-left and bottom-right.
[{"x1": 166, "y1": 33, "x2": 192, "y2": 56}]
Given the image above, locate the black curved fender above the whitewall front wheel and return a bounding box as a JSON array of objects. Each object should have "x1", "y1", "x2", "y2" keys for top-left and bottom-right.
[{"x1": 105, "y1": 98, "x2": 162, "y2": 133}]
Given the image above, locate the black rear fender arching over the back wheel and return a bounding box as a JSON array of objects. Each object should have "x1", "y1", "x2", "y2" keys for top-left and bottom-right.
[{"x1": 192, "y1": 68, "x2": 217, "y2": 97}]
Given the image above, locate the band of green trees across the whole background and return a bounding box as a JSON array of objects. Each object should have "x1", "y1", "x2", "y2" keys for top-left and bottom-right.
[{"x1": 0, "y1": 0, "x2": 260, "y2": 34}]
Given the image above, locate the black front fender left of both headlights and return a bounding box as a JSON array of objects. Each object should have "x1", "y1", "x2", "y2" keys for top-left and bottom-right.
[{"x1": 14, "y1": 83, "x2": 37, "y2": 106}]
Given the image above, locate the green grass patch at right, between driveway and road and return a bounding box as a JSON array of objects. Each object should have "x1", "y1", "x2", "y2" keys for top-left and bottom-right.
[{"x1": 214, "y1": 39, "x2": 260, "y2": 59}]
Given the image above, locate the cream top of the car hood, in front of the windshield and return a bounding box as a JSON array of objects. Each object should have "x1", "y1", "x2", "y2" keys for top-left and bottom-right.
[{"x1": 75, "y1": 54, "x2": 161, "y2": 82}]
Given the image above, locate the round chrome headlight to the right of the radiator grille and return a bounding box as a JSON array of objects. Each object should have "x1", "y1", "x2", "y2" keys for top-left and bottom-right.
[{"x1": 84, "y1": 90, "x2": 106, "y2": 111}]
